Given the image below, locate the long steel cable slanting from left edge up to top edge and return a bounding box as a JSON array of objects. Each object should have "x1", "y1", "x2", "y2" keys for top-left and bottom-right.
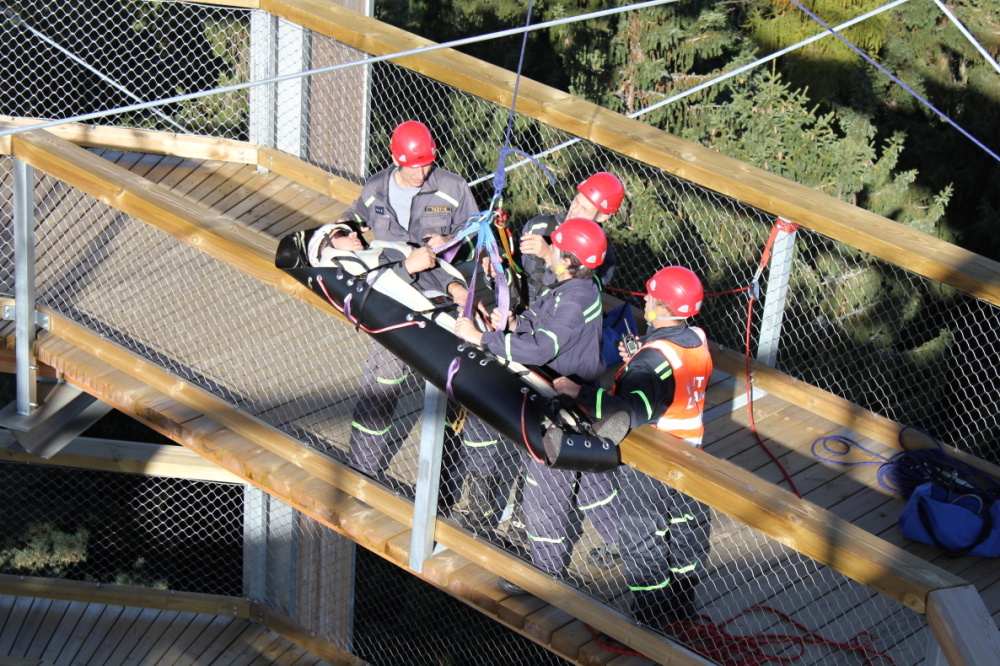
[{"x1": 0, "y1": 0, "x2": 680, "y2": 137}]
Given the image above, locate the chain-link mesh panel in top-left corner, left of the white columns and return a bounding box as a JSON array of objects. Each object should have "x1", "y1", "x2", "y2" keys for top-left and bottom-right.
[{"x1": 0, "y1": 1, "x2": 250, "y2": 138}]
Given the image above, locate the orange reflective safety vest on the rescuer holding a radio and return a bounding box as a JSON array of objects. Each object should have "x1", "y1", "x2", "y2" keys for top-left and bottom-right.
[{"x1": 641, "y1": 326, "x2": 712, "y2": 447}]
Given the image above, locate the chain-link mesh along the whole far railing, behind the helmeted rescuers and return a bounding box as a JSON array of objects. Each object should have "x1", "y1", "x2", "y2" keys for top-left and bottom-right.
[{"x1": 0, "y1": 2, "x2": 1000, "y2": 458}]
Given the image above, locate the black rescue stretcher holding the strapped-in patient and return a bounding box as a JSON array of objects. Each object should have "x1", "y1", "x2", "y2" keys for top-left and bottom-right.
[{"x1": 275, "y1": 229, "x2": 624, "y2": 472}]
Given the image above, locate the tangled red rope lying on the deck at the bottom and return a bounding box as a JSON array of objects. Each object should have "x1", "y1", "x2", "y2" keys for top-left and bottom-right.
[{"x1": 585, "y1": 606, "x2": 896, "y2": 666}]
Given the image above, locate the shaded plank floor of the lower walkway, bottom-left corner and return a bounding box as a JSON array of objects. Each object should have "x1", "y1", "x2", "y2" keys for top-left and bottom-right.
[{"x1": 0, "y1": 595, "x2": 327, "y2": 666}]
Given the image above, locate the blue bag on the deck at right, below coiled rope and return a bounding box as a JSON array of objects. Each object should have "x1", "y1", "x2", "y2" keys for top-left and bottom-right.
[{"x1": 899, "y1": 481, "x2": 1000, "y2": 557}]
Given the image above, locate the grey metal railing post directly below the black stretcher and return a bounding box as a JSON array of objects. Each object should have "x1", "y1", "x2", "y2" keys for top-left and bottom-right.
[{"x1": 410, "y1": 382, "x2": 448, "y2": 573}]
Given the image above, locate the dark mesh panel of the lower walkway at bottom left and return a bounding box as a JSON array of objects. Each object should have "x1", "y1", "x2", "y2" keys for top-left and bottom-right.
[{"x1": 0, "y1": 463, "x2": 243, "y2": 596}]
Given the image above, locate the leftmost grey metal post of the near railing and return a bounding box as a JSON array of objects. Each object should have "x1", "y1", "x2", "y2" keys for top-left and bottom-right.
[{"x1": 14, "y1": 158, "x2": 38, "y2": 416}]
